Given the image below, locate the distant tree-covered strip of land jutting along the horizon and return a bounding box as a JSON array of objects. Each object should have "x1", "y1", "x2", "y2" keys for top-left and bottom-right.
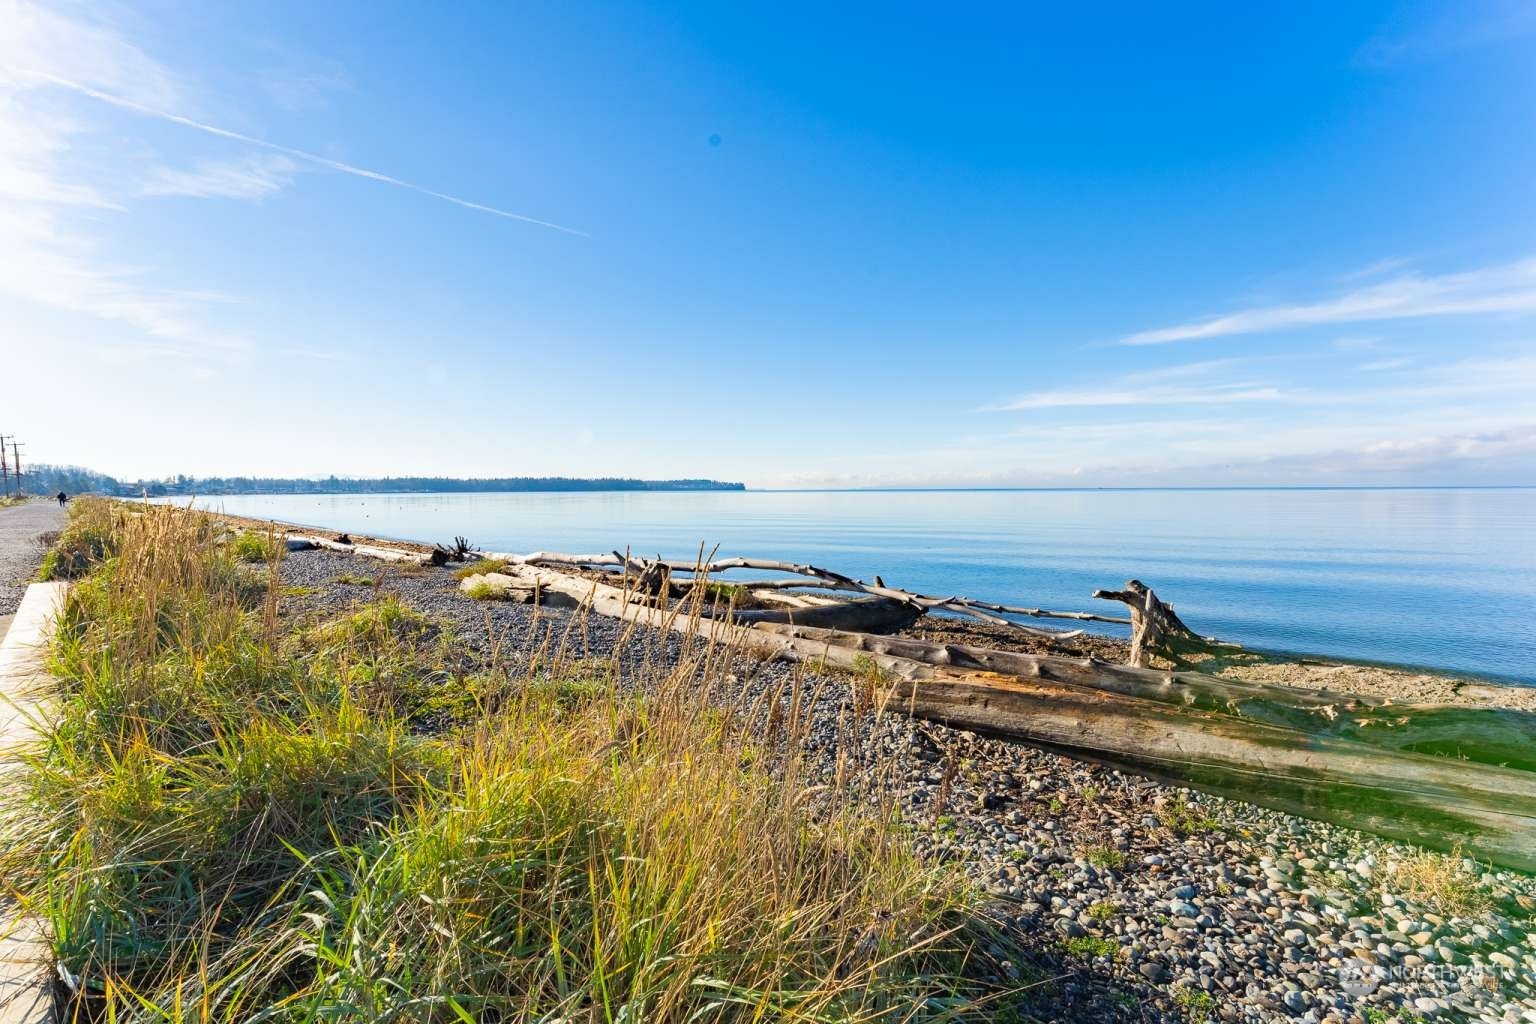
[{"x1": 23, "y1": 465, "x2": 746, "y2": 497}]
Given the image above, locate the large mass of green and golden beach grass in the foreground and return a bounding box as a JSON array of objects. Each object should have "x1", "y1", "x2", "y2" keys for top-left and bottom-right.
[{"x1": 9, "y1": 507, "x2": 1017, "y2": 1022}]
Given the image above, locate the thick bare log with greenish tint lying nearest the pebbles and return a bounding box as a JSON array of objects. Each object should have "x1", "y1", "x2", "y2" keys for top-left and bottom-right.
[{"x1": 891, "y1": 677, "x2": 1536, "y2": 870}]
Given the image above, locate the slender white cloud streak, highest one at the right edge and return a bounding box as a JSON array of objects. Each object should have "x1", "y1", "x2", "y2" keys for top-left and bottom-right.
[{"x1": 1121, "y1": 259, "x2": 1536, "y2": 345}]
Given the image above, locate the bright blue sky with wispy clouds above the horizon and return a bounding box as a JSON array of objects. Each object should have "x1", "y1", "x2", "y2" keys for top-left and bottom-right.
[{"x1": 0, "y1": 0, "x2": 1536, "y2": 487}]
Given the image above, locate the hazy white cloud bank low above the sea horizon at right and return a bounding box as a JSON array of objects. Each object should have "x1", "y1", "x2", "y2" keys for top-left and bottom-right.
[{"x1": 946, "y1": 344, "x2": 1536, "y2": 487}]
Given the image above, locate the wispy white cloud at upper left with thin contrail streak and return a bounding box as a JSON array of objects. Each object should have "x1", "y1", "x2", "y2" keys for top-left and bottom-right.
[{"x1": 0, "y1": 0, "x2": 570, "y2": 368}]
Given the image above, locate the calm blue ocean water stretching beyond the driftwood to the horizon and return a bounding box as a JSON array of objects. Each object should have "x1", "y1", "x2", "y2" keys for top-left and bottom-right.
[{"x1": 179, "y1": 488, "x2": 1536, "y2": 685}]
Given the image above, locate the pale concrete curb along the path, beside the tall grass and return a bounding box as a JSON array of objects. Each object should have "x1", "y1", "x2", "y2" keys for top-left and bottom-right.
[{"x1": 0, "y1": 583, "x2": 69, "y2": 1024}]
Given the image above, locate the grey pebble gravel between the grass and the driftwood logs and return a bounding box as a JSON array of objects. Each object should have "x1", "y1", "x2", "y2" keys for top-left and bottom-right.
[{"x1": 282, "y1": 552, "x2": 1536, "y2": 1024}]
